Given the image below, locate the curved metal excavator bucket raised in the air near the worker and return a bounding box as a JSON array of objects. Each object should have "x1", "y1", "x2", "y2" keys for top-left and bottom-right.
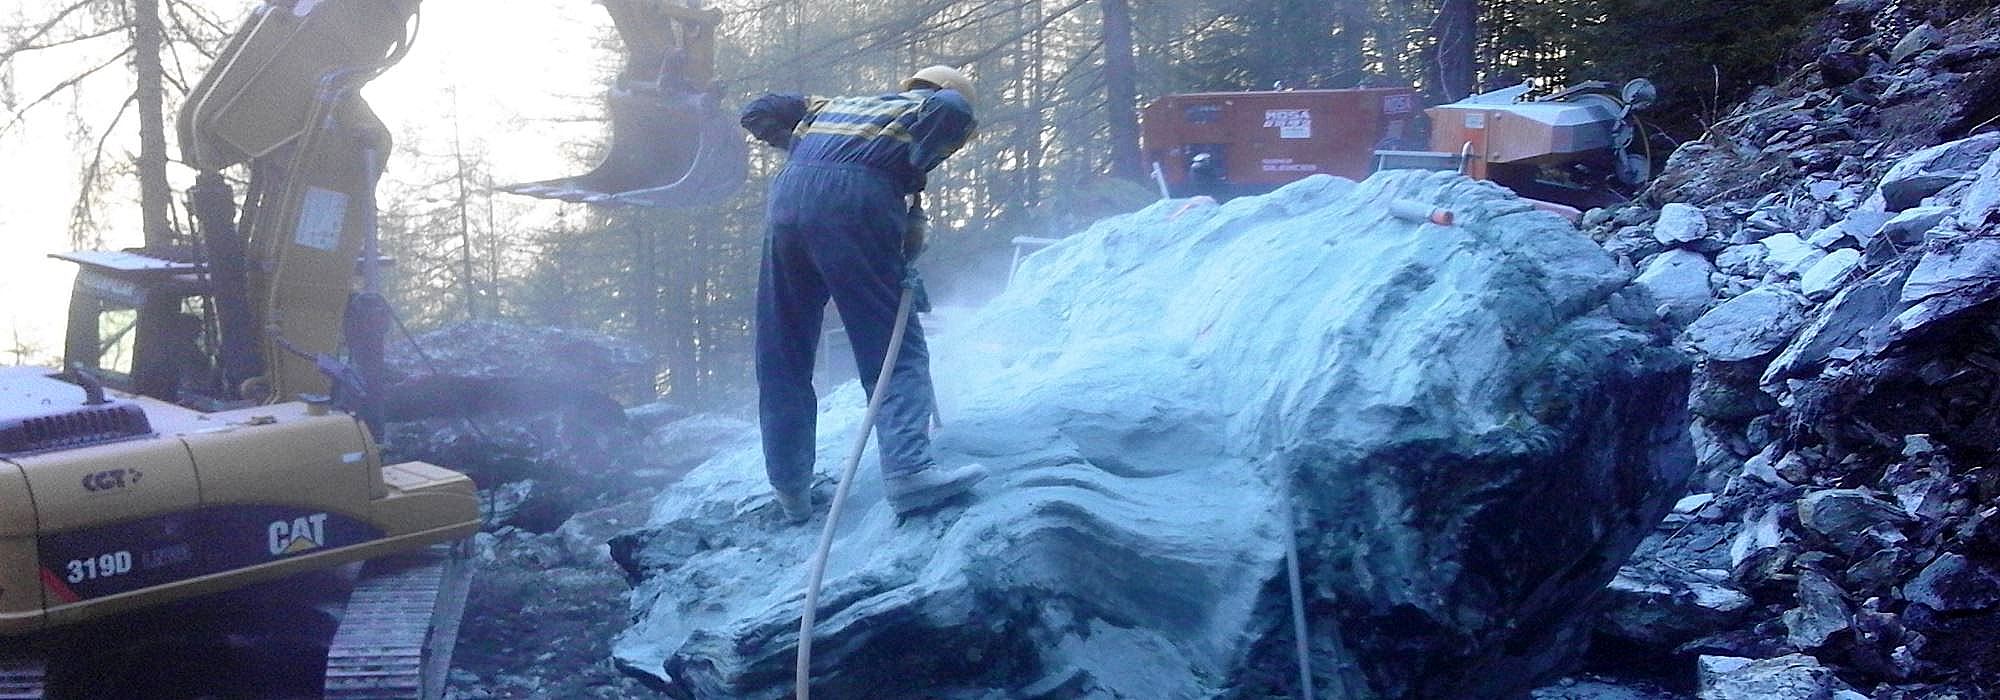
[{"x1": 502, "y1": 0, "x2": 750, "y2": 208}]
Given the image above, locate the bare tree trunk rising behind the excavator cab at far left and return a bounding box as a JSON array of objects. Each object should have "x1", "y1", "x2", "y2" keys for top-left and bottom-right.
[{"x1": 132, "y1": 0, "x2": 174, "y2": 248}]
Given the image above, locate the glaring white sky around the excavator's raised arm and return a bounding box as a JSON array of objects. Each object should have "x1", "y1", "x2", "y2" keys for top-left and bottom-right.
[{"x1": 0, "y1": 0, "x2": 616, "y2": 362}]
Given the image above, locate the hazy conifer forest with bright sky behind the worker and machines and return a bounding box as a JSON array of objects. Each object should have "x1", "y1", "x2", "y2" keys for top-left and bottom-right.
[{"x1": 0, "y1": 0, "x2": 1830, "y2": 406}]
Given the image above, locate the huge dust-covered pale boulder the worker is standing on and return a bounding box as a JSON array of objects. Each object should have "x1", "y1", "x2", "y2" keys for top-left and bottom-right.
[{"x1": 612, "y1": 172, "x2": 1692, "y2": 698}]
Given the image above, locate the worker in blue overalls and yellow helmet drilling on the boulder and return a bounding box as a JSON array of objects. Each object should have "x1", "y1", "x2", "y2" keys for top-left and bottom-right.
[{"x1": 742, "y1": 66, "x2": 986, "y2": 522}]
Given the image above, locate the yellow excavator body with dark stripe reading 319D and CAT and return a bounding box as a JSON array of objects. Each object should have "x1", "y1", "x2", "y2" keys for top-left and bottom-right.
[{"x1": 0, "y1": 368, "x2": 480, "y2": 636}]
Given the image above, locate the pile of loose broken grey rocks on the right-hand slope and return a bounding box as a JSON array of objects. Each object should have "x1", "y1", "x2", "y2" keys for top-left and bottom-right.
[{"x1": 1584, "y1": 0, "x2": 2000, "y2": 700}]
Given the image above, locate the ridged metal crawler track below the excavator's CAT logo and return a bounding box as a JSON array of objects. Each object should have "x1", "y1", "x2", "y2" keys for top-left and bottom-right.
[{"x1": 326, "y1": 544, "x2": 470, "y2": 700}]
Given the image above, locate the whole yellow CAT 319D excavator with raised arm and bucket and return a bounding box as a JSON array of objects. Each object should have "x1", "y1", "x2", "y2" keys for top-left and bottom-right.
[{"x1": 0, "y1": 0, "x2": 748, "y2": 698}]
